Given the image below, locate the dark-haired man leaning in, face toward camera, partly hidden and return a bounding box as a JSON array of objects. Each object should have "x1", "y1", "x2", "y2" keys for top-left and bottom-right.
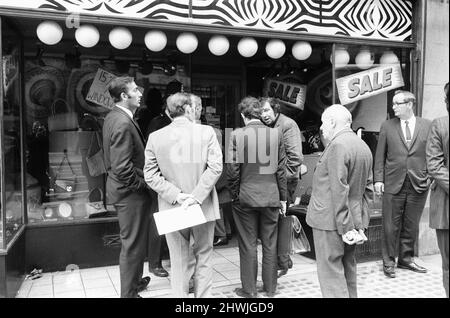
[{"x1": 260, "y1": 97, "x2": 303, "y2": 277}]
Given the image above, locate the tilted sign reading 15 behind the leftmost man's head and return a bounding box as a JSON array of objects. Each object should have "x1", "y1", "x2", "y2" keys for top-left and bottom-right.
[{"x1": 86, "y1": 68, "x2": 116, "y2": 109}]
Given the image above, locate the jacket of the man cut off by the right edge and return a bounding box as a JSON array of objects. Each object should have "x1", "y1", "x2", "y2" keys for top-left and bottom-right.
[{"x1": 426, "y1": 116, "x2": 449, "y2": 230}]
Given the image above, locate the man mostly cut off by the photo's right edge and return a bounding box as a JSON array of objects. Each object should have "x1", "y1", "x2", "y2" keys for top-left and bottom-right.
[{"x1": 426, "y1": 83, "x2": 449, "y2": 298}]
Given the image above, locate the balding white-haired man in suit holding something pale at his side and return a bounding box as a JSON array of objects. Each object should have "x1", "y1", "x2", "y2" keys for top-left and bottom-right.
[{"x1": 306, "y1": 105, "x2": 373, "y2": 298}]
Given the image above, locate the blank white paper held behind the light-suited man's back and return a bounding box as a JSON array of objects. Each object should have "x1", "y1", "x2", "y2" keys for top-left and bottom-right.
[{"x1": 153, "y1": 204, "x2": 206, "y2": 235}]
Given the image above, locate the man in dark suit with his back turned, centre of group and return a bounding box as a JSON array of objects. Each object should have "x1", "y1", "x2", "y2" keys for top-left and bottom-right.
[{"x1": 226, "y1": 97, "x2": 287, "y2": 298}]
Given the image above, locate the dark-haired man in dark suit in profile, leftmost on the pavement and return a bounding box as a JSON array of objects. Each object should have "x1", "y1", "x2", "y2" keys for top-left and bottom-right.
[{"x1": 103, "y1": 77, "x2": 151, "y2": 298}]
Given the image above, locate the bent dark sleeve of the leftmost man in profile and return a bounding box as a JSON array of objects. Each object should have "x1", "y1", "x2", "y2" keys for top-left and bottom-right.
[{"x1": 110, "y1": 123, "x2": 147, "y2": 191}]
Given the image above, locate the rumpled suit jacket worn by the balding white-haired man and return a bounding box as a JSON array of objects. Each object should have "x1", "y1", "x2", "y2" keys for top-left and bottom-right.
[{"x1": 306, "y1": 128, "x2": 373, "y2": 235}]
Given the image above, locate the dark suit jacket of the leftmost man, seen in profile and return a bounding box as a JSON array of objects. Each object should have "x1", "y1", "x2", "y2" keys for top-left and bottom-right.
[{"x1": 103, "y1": 107, "x2": 148, "y2": 204}]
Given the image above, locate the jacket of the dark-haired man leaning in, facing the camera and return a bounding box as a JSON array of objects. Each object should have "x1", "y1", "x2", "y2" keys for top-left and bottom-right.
[{"x1": 273, "y1": 113, "x2": 303, "y2": 179}]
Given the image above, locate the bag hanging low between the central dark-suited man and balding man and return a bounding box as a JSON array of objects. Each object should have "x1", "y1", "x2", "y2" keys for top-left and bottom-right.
[{"x1": 277, "y1": 215, "x2": 311, "y2": 255}]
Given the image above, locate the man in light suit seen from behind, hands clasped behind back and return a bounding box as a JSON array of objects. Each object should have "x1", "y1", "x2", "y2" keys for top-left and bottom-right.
[{"x1": 144, "y1": 93, "x2": 222, "y2": 298}]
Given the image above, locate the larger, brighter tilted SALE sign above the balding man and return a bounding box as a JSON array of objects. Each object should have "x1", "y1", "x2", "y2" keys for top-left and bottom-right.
[{"x1": 336, "y1": 64, "x2": 405, "y2": 105}]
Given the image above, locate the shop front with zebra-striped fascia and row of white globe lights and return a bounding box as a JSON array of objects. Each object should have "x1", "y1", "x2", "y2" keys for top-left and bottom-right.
[{"x1": 0, "y1": 0, "x2": 421, "y2": 297}]
